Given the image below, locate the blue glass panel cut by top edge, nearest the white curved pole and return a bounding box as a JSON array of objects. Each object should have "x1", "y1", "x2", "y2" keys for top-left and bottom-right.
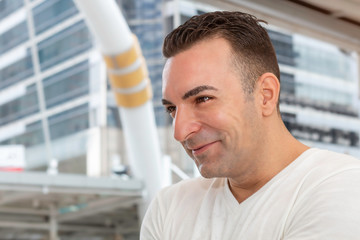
[{"x1": 34, "y1": 0, "x2": 78, "y2": 34}]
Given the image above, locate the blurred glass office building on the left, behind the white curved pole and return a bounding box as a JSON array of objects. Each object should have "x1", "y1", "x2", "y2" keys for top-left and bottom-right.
[{"x1": 0, "y1": 0, "x2": 167, "y2": 175}]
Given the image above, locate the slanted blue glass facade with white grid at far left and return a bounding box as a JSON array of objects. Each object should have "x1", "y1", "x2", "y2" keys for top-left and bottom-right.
[{"x1": 0, "y1": 0, "x2": 94, "y2": 169}]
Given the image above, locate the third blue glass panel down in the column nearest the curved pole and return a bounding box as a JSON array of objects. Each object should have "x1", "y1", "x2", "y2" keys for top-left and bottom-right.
[{"x1": 44, "y1": 62, "x2": 89, "y2": 108}]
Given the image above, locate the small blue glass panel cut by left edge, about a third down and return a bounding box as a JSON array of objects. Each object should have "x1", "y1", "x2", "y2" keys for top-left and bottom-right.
[{"x1": 0, "y1": 51, "x2": 34, "y2": 89}]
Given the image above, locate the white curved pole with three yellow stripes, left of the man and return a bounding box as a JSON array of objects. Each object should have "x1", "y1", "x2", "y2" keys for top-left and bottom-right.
[{"x1": 74, "y1": 0, "x2": 163, "y2": 202}]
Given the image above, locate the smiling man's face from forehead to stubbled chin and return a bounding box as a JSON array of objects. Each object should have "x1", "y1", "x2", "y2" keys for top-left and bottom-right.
[{"x1": 163, "y1": 38, "x2": 261, "y2": 178}]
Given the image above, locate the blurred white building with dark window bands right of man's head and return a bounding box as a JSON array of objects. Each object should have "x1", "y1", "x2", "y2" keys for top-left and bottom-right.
[{"x1": 269, "y1": 30, "x2": 360, "y2": 157}]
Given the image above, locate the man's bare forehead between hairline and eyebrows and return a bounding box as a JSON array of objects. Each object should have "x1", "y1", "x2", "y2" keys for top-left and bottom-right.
[{"x1": 163, "y1": 38, "x2": 233, "y2": 98}]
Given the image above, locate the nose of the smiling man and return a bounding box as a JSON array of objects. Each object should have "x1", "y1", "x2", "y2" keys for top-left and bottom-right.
[{"x1": 173, "y1": 107, "x2": 201, "y2": 142}]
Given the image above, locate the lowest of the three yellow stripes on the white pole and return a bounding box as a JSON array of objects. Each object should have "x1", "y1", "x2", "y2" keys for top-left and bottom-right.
[{"x1": 114, "y1": 84, "x2": 152, "y2": 108}]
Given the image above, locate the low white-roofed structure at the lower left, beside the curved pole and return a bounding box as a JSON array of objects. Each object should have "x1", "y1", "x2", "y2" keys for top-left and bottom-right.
[{"x1": 0, "y1": 172, "x2": 143, "y2": 240}]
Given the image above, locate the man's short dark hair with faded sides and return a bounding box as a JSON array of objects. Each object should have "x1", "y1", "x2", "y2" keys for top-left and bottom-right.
[{"x1": 163, "y1": 11, "x2": 280, "y2": 93}]
